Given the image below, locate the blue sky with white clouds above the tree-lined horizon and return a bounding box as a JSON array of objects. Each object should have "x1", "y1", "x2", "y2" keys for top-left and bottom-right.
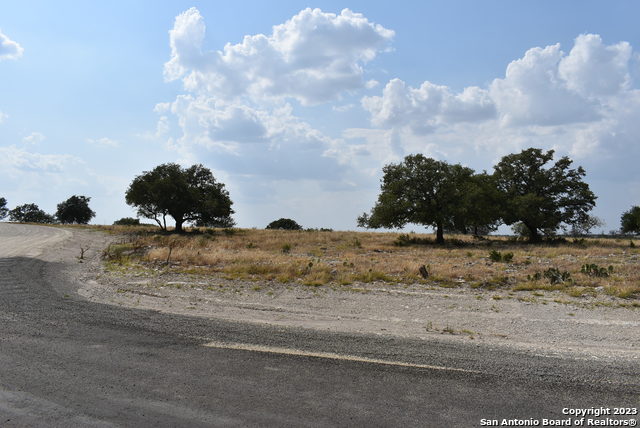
[{"x1": 0, "y1": 0, "x2": 640, "y2": 232}]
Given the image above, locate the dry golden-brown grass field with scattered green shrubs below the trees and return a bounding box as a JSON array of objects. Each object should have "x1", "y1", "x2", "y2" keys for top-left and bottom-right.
[{"x1": 96, "y1": 226, "x2": 640, "y2": 301}]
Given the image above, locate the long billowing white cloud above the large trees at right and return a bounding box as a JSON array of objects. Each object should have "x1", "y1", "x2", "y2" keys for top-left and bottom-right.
[{"x1": 362, "y1": 34, "x2": 636, "y2": 150}]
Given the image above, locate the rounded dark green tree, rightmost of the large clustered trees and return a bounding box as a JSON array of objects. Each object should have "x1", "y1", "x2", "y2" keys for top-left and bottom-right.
[{"x1": 493, "y1": 148, "x2": 596, "y2": 242}]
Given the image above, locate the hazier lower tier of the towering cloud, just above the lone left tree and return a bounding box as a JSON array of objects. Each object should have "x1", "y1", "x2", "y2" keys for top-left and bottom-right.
[{"x1": 172, "y1": 95, "x2": 339, "y2": 180}]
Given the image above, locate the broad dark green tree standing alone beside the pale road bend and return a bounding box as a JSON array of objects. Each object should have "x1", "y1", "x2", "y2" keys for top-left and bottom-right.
[{"x1": 126, "y1": 163, "x2": 234, "y2": 232}]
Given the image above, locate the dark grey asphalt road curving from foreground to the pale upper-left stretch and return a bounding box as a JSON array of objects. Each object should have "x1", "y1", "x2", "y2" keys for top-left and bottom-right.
[{"x1": 0, "y1": 224, "x2": 640, "y2": 427}]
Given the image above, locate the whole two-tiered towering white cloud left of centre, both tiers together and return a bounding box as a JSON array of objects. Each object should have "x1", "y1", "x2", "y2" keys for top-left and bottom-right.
[{"x1": 159, "y1": 8, "x2": 394, "y2": 181}]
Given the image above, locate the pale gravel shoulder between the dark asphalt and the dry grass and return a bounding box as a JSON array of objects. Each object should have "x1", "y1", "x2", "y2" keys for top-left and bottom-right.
[{"x1": 40, "y1": 229, "x2": 640, "y2": 361}]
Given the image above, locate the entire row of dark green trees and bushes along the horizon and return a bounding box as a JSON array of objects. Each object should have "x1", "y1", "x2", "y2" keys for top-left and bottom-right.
[{"x1": 0, "y1": 148, "x2": 640, "y2": 243}]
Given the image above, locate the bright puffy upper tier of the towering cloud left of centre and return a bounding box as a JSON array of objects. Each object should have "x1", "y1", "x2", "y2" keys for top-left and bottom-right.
[{"x1": 164, "y1": 8, "x2": 394, "y2": 104}]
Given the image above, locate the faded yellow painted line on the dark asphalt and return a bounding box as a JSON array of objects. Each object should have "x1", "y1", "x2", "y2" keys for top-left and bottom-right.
[{"x1": 203, "y1": 342, "x2": 480, "y2": 373}]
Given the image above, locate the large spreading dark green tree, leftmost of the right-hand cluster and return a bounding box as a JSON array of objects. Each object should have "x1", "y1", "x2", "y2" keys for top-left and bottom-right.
[{"x1": 358, "y1": 154, "x2": 473, "y2": 244}]
